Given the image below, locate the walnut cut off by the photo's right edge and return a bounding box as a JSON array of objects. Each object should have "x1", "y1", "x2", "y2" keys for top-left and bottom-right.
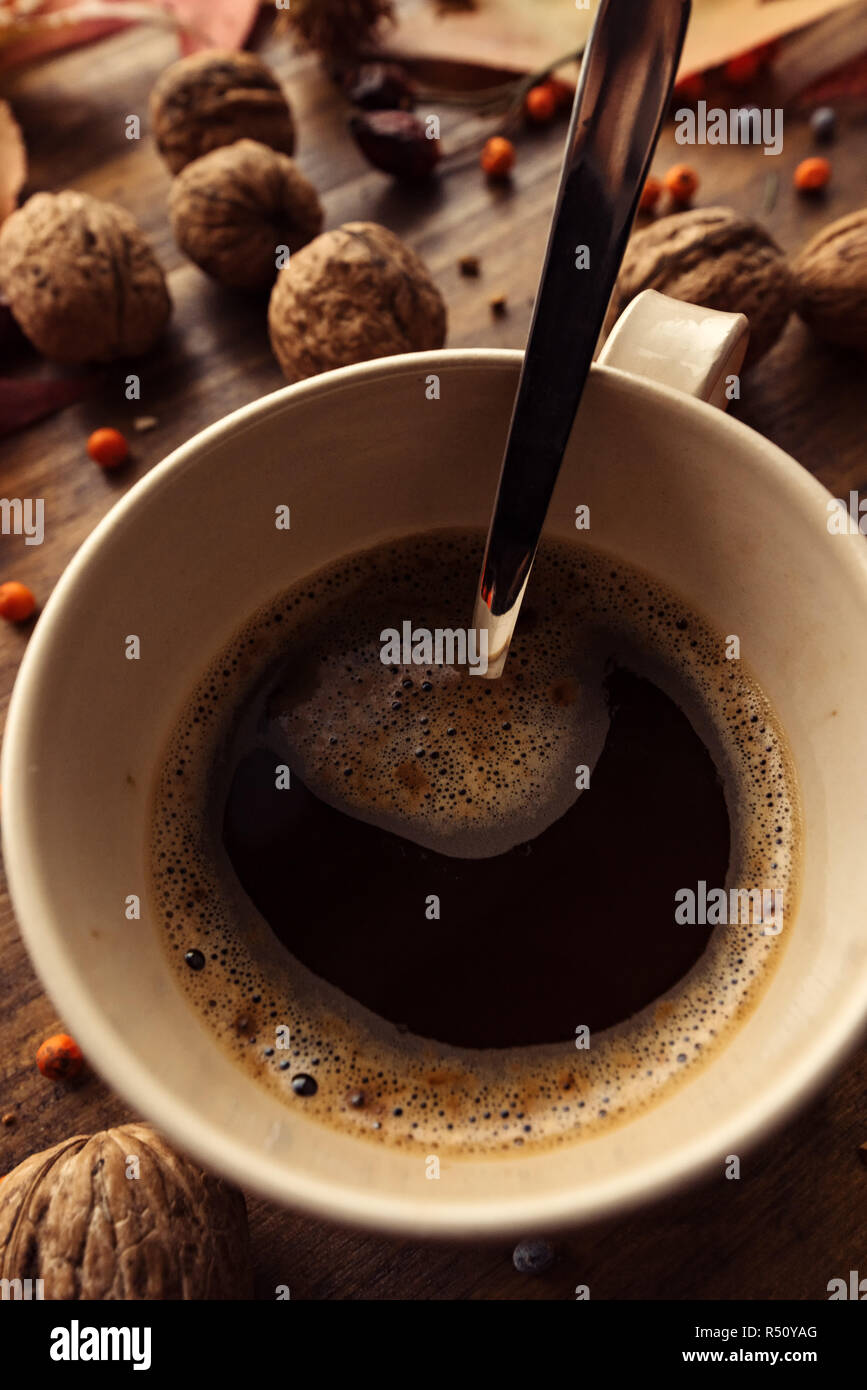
[{"x1": 792, "y1": 207, "x2": 867, "y2": 352}]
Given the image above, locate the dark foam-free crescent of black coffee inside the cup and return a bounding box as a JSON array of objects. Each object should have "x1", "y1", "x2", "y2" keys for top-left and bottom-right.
[{"x1": 224, "y1": 670, "x2": 729, "y2": 1048}]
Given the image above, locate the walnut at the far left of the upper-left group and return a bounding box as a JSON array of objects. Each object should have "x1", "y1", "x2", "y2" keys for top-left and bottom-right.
[{"x1": 0, "y1": 192, "x2": 171, "y2": 363}]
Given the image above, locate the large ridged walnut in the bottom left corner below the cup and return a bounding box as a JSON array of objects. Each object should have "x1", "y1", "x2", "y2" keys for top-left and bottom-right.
[{"x1": 0, "y1": 1125, "x2": 251, "y2": 1300}]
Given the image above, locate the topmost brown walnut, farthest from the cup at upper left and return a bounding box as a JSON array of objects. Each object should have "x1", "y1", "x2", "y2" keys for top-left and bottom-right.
[{"x1": 150, "y1": 49, "x2": 295, "y2": 174}]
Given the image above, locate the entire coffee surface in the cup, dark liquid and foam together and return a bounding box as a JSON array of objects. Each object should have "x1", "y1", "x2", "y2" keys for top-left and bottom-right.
[{"x1": 153, "y1": 532, "x2": 799, "y2": 1152}]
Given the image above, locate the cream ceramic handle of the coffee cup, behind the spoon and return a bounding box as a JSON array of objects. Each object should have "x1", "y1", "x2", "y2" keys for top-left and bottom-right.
[{"x1": 597, "y1": 289, "x2": 749, "y2": 410}]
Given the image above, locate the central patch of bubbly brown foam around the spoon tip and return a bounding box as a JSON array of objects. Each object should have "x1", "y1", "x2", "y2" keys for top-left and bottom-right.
[{"x1": 264, "y1": 557, "x2": 609, "y2": 859}]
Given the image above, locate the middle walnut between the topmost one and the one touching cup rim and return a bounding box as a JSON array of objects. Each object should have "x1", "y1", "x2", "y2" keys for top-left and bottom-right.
[{"x1": 168, "y1": 140, "x2": 322, "y2": 289}]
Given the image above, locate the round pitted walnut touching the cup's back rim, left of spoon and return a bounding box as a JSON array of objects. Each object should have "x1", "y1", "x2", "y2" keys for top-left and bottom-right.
[{"x1": 268, "y1": 222, "x2": 446, "y2": 381}]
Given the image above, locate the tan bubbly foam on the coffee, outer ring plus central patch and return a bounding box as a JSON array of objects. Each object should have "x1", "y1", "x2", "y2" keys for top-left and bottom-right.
[{"x1": 151, "y1": 532, "x2": 800, "y2": 1156}]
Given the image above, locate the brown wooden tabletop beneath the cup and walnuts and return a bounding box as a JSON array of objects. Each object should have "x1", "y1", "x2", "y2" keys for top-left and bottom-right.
[{"x1": 0, "y1": 16, "x2": 867, "y2": 1300}]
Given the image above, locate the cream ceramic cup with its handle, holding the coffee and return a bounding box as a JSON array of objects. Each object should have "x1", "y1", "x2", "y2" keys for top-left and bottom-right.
[{"x1": 3, "y1": 296, "x2": 867, "y2": 1233}]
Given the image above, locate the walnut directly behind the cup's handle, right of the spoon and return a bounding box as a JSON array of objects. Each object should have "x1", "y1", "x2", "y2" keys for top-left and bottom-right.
[{"x1": 606, "y1": 207, "x2": 793, "y2": 367}]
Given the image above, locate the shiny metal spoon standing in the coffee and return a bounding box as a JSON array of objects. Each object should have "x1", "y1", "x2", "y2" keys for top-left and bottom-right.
[{"x1": 472, "y1": 0, "x2": 691, "y2": 677}]
